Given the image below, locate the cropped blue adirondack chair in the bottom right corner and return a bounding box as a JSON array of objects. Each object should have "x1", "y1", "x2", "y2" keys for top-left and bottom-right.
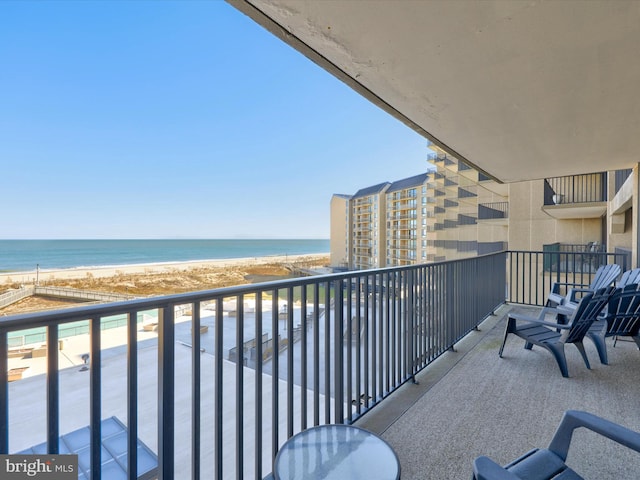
[{"x1": 473, "y1": 410, "x2": 640, "y2": 480}]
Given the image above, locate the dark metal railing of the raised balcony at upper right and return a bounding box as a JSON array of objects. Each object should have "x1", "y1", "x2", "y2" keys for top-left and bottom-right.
[{"x1": 544, "y1": 172, "x2": 607, "y2": 205}]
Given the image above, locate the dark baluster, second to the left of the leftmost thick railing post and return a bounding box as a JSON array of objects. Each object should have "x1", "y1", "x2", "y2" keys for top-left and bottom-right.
[{"x1": 89, "y1": 317, "x2": 100, "y2": 480}]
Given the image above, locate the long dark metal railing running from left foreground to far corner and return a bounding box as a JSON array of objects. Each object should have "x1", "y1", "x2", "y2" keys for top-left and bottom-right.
[{"x1": 0, "y1": 252, "x2": 507, "y2": 480}]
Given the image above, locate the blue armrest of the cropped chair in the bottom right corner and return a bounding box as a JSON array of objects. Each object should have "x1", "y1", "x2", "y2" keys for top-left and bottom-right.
[{"x1": 549, "y1": 410, "x2": 640, "y2": 460}]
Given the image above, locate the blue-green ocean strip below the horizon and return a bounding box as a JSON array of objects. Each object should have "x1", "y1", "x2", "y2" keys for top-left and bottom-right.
[{"x1": 0, "y1": 239, "x2": 329, "y2": 272}]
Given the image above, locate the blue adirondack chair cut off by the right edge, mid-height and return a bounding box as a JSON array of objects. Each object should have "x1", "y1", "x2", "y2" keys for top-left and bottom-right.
[{"x1": 587, "y1": 283, "x2": 640, "y2": 365}]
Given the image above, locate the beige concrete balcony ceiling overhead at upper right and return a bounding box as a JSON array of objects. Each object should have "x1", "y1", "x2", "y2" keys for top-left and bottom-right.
[{"x1": 234, "y1": 0, "x2": 640, "y2": 182}]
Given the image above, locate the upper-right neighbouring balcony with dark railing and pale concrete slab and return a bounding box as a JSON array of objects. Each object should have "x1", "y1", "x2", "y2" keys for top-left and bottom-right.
[{"x1": 542, "y1": 172, "x2": 607, "y2": 219}]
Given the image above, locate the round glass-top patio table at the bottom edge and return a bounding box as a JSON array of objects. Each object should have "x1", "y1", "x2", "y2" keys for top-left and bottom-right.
[{"x1": 273, "y1": 425, "x2": 400, "y2": 480}]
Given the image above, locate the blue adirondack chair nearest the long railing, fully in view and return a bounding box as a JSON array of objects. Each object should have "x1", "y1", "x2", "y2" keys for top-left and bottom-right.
[{"x1": 498, "y1": 287, "x2": 615, "y2": 377}]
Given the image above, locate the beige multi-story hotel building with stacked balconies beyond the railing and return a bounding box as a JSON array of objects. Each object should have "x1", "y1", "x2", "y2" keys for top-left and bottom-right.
[{"x1": 331, "y1": 145, "x2": 633, "y2": 269}]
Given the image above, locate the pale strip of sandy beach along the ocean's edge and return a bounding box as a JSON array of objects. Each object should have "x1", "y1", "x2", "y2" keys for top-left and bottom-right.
[{"x1": 0, "y1": 253, "x2": 328, "y2": 289}]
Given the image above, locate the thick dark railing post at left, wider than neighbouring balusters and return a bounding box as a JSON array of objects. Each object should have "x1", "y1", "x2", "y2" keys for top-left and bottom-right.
[{"x1": 158, "y1": 304, "x2": 175, "y2": 480}]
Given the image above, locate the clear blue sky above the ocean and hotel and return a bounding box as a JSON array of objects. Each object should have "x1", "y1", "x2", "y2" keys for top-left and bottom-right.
[{"x1": 0, "y1": 0, "x2": 428, "y2": 239}]
